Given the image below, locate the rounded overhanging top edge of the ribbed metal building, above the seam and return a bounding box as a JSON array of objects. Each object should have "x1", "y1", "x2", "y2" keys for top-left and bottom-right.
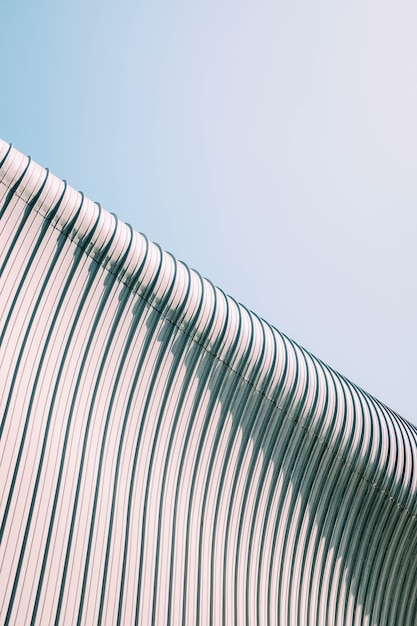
[{"x1": 0, "y1": 142, "x2": 417, "y2": 510}]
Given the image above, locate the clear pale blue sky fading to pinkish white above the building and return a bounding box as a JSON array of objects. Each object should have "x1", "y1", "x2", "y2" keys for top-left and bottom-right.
[{"x1": 0, "y1": 0, "x2": 417, "y2": 424}]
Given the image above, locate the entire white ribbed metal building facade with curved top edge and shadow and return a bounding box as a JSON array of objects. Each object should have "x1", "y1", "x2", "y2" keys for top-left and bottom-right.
[{"x1": 0, "y1": 142, "x2": 417, "y2": 626}]
